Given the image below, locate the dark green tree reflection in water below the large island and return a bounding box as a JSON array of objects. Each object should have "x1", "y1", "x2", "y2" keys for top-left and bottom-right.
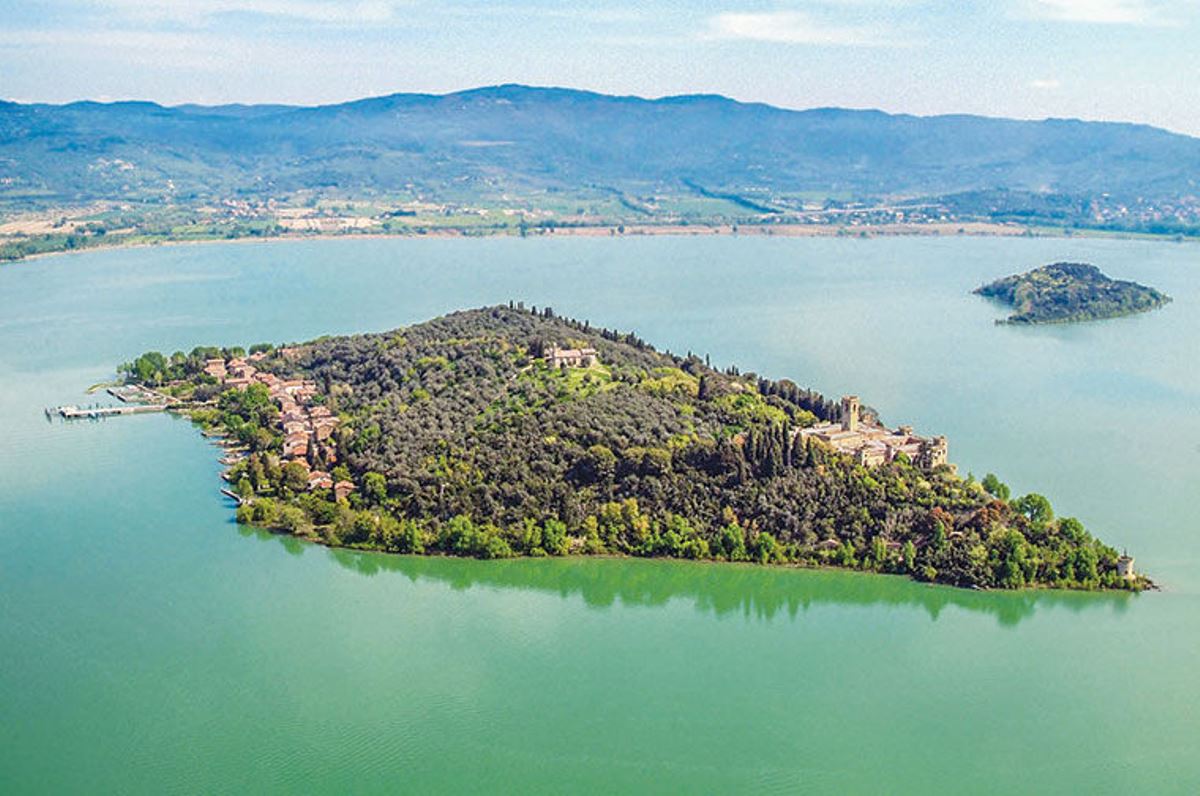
[{"x1": 244, "y1": 529, "x2": 1138, "y2": 627}]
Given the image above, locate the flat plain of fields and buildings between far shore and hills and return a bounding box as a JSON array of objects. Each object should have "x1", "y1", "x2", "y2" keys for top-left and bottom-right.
[{"x1": 0, "y1": 192, "x2": 1200, "y2": 262}]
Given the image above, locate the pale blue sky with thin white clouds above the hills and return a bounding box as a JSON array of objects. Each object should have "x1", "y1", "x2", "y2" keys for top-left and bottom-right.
[{"x1": 0, "y1": 0, "x2": 1200, "y2": 136}]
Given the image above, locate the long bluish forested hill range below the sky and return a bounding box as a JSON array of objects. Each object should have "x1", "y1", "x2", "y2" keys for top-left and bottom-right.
[{"x1": 0, "y1": 85, "x2": 1200, "y2": 210}]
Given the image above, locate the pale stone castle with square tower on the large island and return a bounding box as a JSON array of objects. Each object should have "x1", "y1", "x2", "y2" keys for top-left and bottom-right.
[{"x1": 797, "y1": 395, "x2": 949, "y2": 469}]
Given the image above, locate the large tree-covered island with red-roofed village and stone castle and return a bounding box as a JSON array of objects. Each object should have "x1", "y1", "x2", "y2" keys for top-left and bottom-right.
[{"x1": 114, "y1": 303, "x2": 1151, "y2": 591}]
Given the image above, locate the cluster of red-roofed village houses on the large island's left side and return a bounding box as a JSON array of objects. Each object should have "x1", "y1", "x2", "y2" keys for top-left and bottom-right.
[{"x1": 204, "y1": 349, "x2": 355, "y2": 499}]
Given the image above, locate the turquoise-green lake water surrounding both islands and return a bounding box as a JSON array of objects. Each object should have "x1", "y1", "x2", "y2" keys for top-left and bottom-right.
[{"x1": 0, "y1": 238, "x2": 1200, "y2": 794}]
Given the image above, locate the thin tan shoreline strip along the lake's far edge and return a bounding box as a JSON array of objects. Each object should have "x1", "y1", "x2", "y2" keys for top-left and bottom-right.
[{"x1": 0, "y1": 221, "x2": 1200, "y2": 268}]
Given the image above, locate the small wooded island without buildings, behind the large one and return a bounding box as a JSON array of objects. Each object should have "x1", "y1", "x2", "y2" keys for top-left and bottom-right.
[{"x1": 974, "y1": 263, "x2": 1171, "y2": 324}]
